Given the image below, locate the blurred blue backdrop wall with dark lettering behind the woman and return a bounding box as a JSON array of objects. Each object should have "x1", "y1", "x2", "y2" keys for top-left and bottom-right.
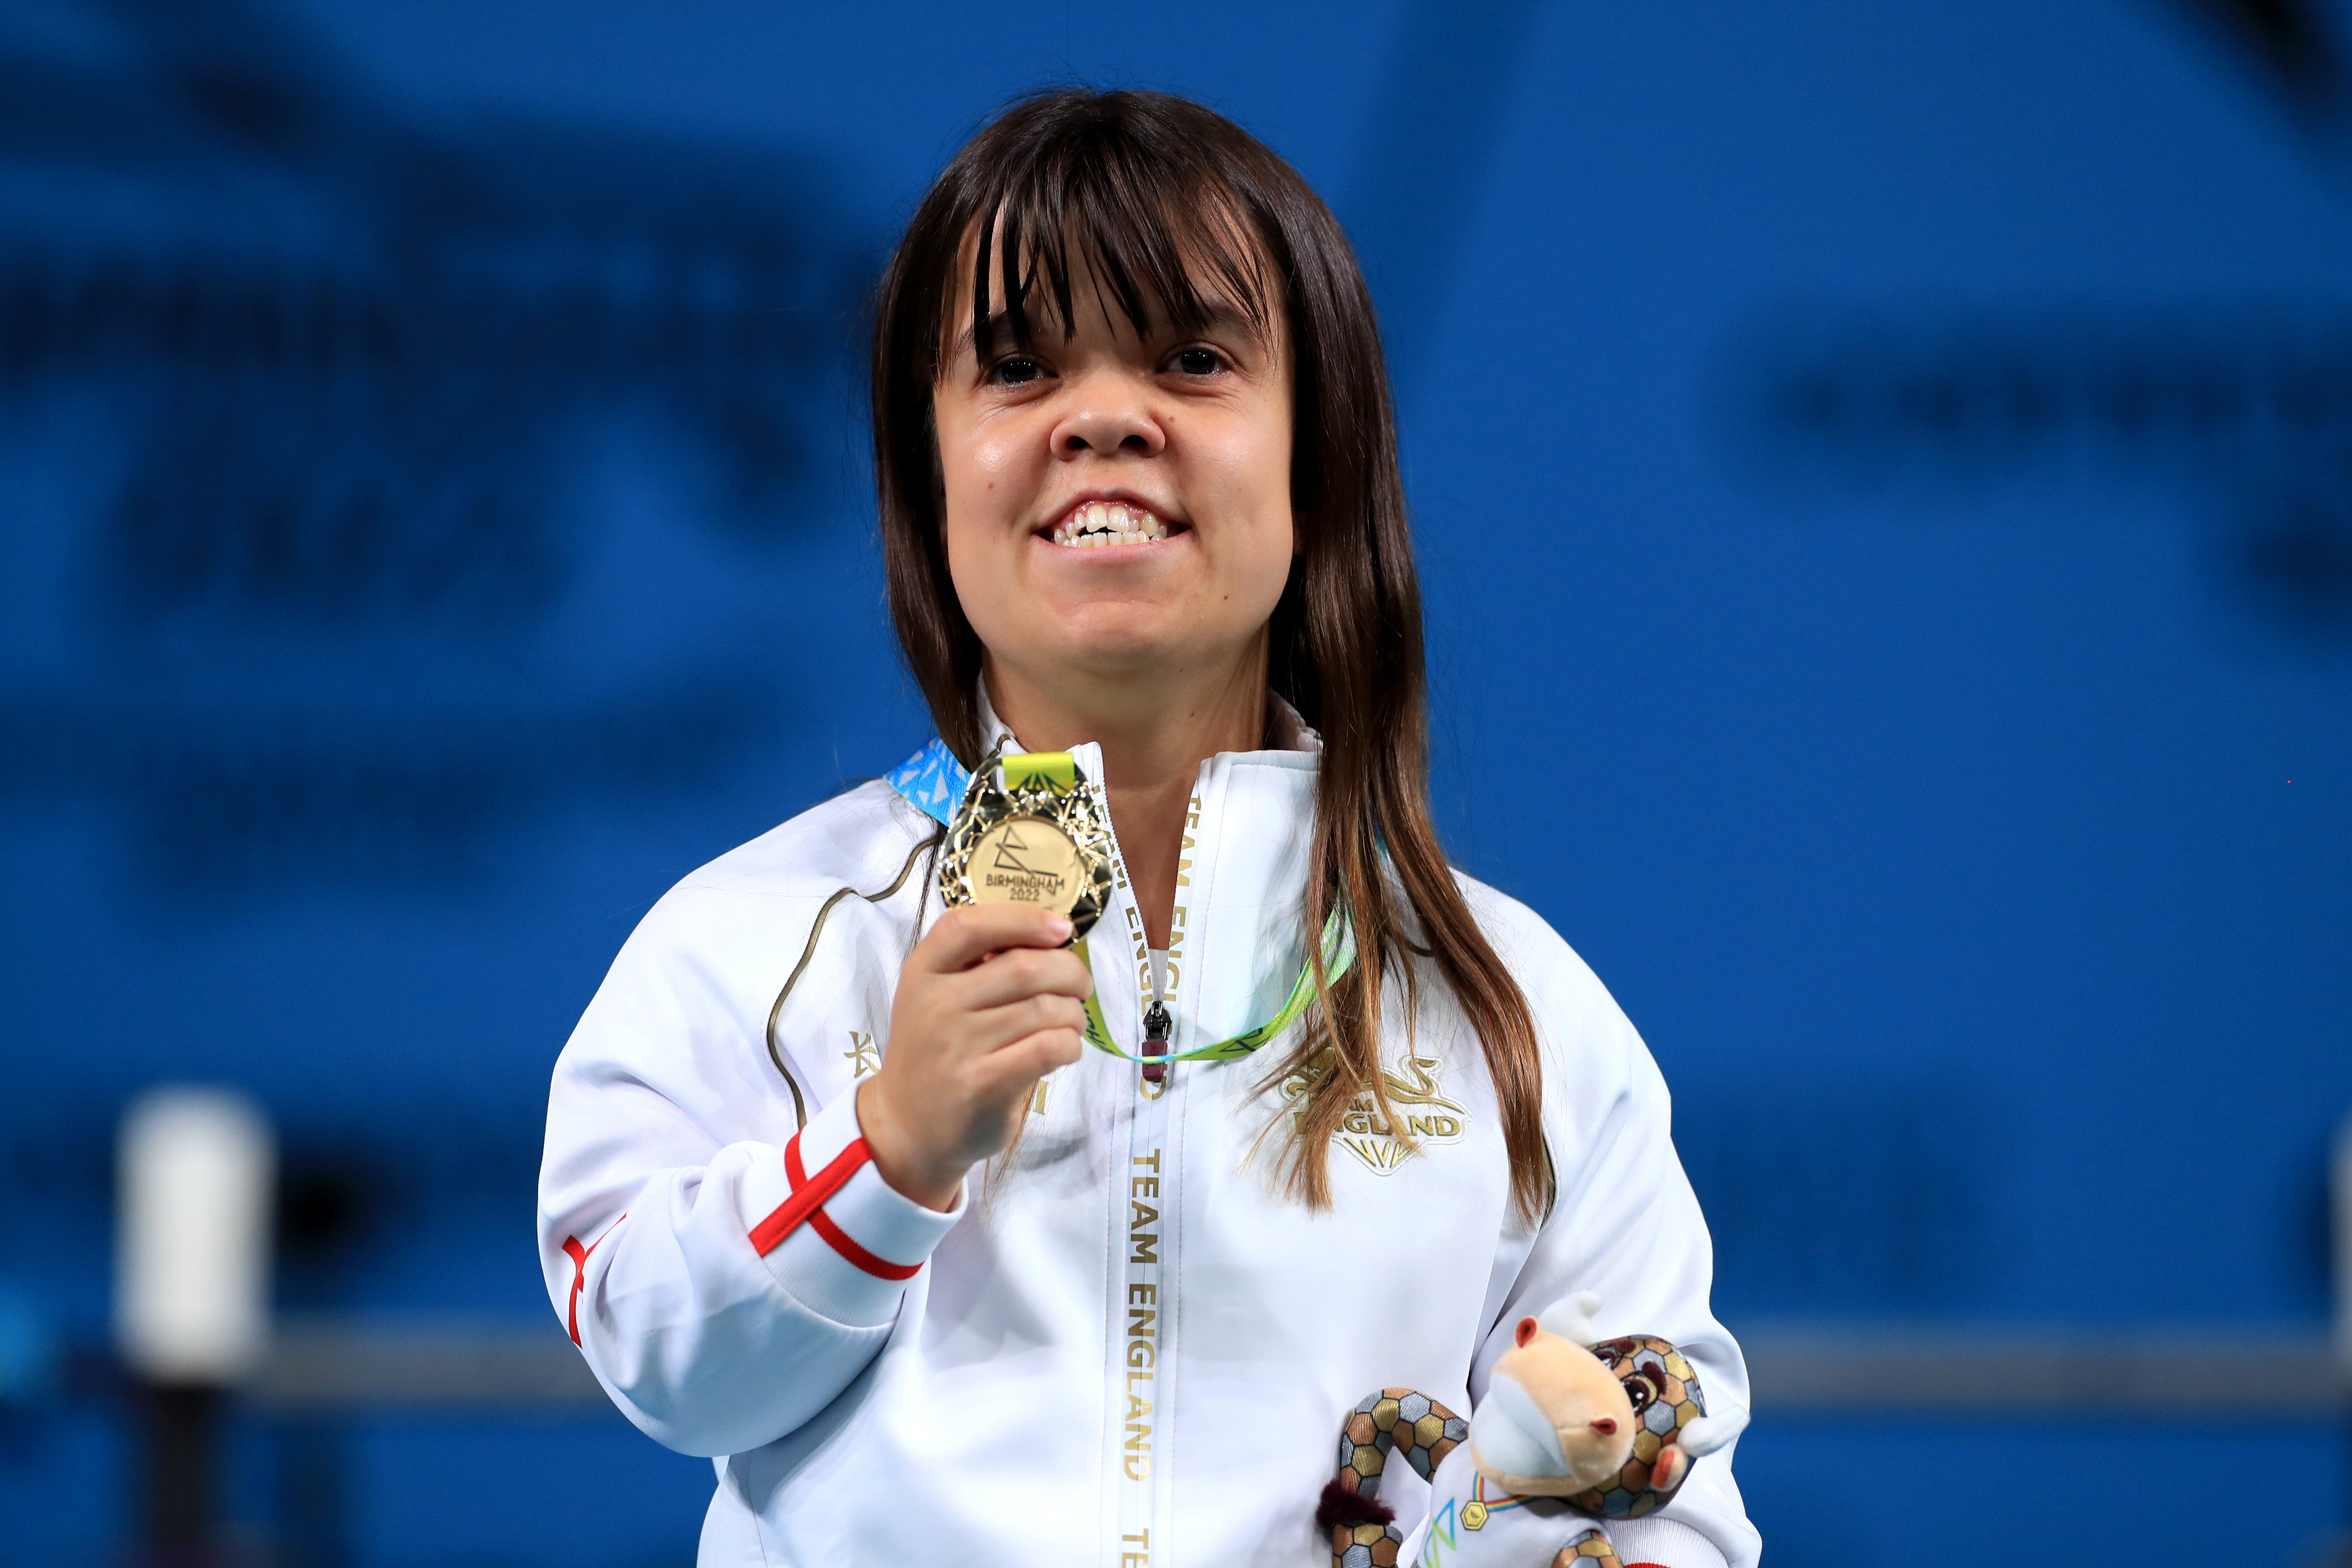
[{"x1": 0, "y1": 0, "x2": 2352, "y2": 1568}]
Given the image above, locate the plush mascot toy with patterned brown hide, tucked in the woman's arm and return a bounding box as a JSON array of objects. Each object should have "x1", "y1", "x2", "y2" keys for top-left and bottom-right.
[{"x1": 1315, "y1": 1293, "x2": 1745, "y2": 1568}]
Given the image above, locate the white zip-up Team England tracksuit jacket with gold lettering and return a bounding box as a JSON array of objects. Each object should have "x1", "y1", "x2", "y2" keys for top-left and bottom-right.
[{"x1": 539, "y1": 710, "x2": 1759, "y2": 1568}]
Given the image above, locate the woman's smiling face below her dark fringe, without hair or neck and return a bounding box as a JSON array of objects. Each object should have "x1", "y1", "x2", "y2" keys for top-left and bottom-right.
[{"x1": 934, "y1": 256, "x2": 1294, "y2": 693}]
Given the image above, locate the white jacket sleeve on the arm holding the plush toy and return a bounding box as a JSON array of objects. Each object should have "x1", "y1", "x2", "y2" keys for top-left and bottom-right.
[{"x1": 1470, "y1": 907, "x2": 1762, "y2": 1568}]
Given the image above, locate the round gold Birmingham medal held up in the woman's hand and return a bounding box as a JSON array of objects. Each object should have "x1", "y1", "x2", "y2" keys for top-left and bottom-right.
[{"x1": 938, "y1": 752, "x2": 1113, "y2": 941}]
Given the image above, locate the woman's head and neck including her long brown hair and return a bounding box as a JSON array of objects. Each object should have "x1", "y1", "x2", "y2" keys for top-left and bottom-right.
[{"x1": 873, "y1": 92, "x2": 1548, "y2": 1216}]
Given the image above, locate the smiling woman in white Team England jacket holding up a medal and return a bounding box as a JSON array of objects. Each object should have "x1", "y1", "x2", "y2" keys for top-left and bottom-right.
[{"x1": 539, "y1": 89, "x2": 1757, "y2": 1568}]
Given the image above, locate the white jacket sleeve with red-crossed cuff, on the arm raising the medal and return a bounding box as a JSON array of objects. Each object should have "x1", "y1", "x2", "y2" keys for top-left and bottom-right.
[{"x1": 539, "y1": 905, "x2": 962, "y2": 1458}]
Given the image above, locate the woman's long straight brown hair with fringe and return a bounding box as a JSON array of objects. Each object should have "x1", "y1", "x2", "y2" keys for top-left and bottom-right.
[{"x1": 873, "y1": 87, "x2": 1550, "y2": 1218}]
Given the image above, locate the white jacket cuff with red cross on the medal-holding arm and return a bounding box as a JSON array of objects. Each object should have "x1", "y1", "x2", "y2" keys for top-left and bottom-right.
[{"x1": 743, "y1": 1093, "x2": 967, "y2": 1328}]
